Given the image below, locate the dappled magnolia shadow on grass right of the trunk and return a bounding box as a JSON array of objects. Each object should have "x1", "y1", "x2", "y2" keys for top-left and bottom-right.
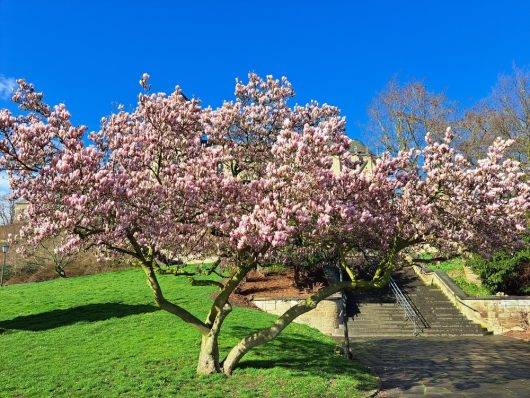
[{"x1": 225, "y1": 326, "x2": 374, "y2": 390}]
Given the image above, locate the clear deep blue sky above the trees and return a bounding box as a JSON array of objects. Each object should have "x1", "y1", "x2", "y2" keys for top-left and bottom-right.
[{"x1": 0, "y1": 0, "x2": 530, "y2": 138}]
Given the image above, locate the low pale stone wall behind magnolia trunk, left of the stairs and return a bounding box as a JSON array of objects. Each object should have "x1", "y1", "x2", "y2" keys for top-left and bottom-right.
[{"x1": 252, "y1": 293, "x2": 341, "y2": 335}]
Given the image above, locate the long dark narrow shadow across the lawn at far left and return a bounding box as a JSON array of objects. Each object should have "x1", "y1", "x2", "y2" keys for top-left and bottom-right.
[{"x1": 0, "y1": 303, "x2": 159, "y2": 334}]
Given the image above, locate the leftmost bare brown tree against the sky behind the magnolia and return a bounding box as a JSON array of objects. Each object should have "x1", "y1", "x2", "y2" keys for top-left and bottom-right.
[{"x1": 368, "y1": 78, "x2": 457, "y2": 154}]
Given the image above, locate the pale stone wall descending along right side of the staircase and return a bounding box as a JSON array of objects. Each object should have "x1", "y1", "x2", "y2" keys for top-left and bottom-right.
[{"x1": 414, "y1": 266, "x2": 530, "y2": 334}]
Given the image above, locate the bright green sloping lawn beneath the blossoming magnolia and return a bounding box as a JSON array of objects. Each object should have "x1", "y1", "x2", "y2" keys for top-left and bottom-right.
[{"x1": 0, "y1": 270, "x2": 376, "y2": 398}]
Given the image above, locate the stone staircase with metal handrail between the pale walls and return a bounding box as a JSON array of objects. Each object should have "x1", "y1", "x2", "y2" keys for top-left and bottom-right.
[{"x1": 333, "y1": 269, "x2": 489, "y2": 338}]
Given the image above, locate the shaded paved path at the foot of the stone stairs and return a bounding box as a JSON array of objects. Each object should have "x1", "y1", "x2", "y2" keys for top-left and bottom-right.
[{"x1": 351, "y1": 336, "x2": 530, "y2": 398}]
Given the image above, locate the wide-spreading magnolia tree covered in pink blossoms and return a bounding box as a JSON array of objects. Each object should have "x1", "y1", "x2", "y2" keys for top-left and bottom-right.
[{"x1": 0, "y1": 74, "x2": 530, "y2": 374}]
